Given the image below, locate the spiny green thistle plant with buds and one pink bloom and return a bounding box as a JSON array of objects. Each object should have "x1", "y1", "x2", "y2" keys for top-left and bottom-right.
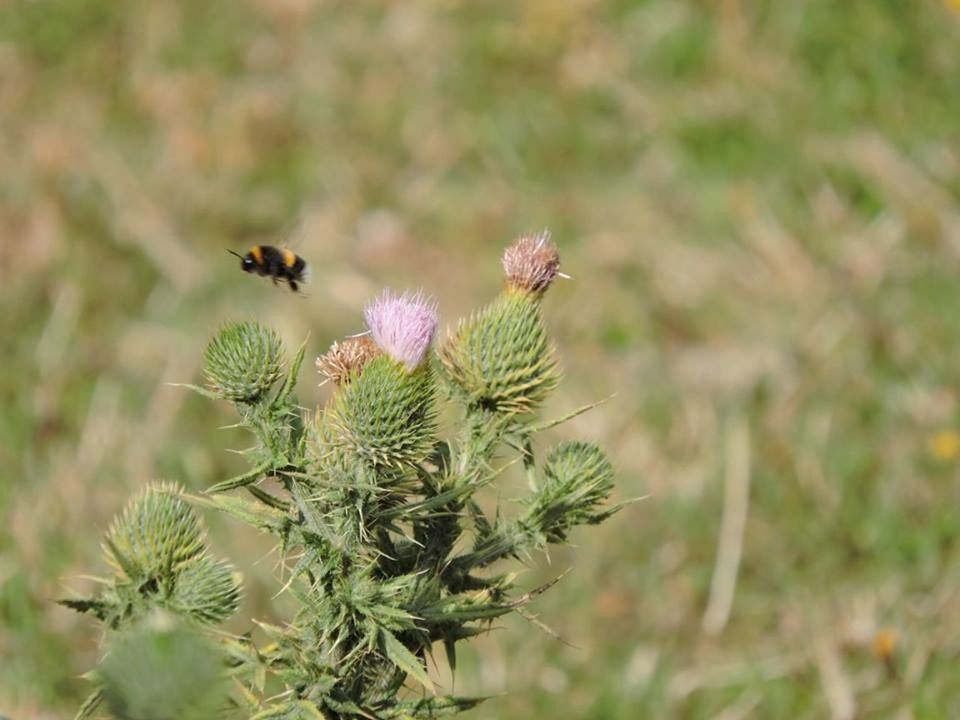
[{"x1": 63, "y1": 233, "x2": 619, "y2": 720}]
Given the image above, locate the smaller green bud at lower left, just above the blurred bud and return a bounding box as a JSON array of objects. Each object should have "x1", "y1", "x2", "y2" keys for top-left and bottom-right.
[{"x1": 168, "y1": 556, "x2": 240, "y2": 623}]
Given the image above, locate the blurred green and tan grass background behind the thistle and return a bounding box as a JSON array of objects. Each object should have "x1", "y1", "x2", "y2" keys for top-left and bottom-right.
[{"x1": 0, "y1": 0, "x2": 960, "y2": 720}]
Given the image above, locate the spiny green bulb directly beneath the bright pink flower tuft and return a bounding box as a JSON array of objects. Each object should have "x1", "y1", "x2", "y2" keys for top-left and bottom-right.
[{"x1": 323, "y1": 355, "x2": 435, "y2": 468}]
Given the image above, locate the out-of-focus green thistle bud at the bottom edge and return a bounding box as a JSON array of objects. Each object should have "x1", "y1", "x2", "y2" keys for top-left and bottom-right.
[{"x1": 97, "y1": 616, "x2": 226, "y2": 720}]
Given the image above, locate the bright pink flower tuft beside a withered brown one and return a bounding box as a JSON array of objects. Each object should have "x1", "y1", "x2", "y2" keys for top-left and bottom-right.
[{"x1": 363, "y1": 289, "x2": 438, "y2": 370}]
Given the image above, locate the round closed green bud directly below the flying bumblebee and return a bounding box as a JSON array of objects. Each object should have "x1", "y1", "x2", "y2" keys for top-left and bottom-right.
[{"x1": 203, "y1": 321, "x2": 283, "y2": 403}]
